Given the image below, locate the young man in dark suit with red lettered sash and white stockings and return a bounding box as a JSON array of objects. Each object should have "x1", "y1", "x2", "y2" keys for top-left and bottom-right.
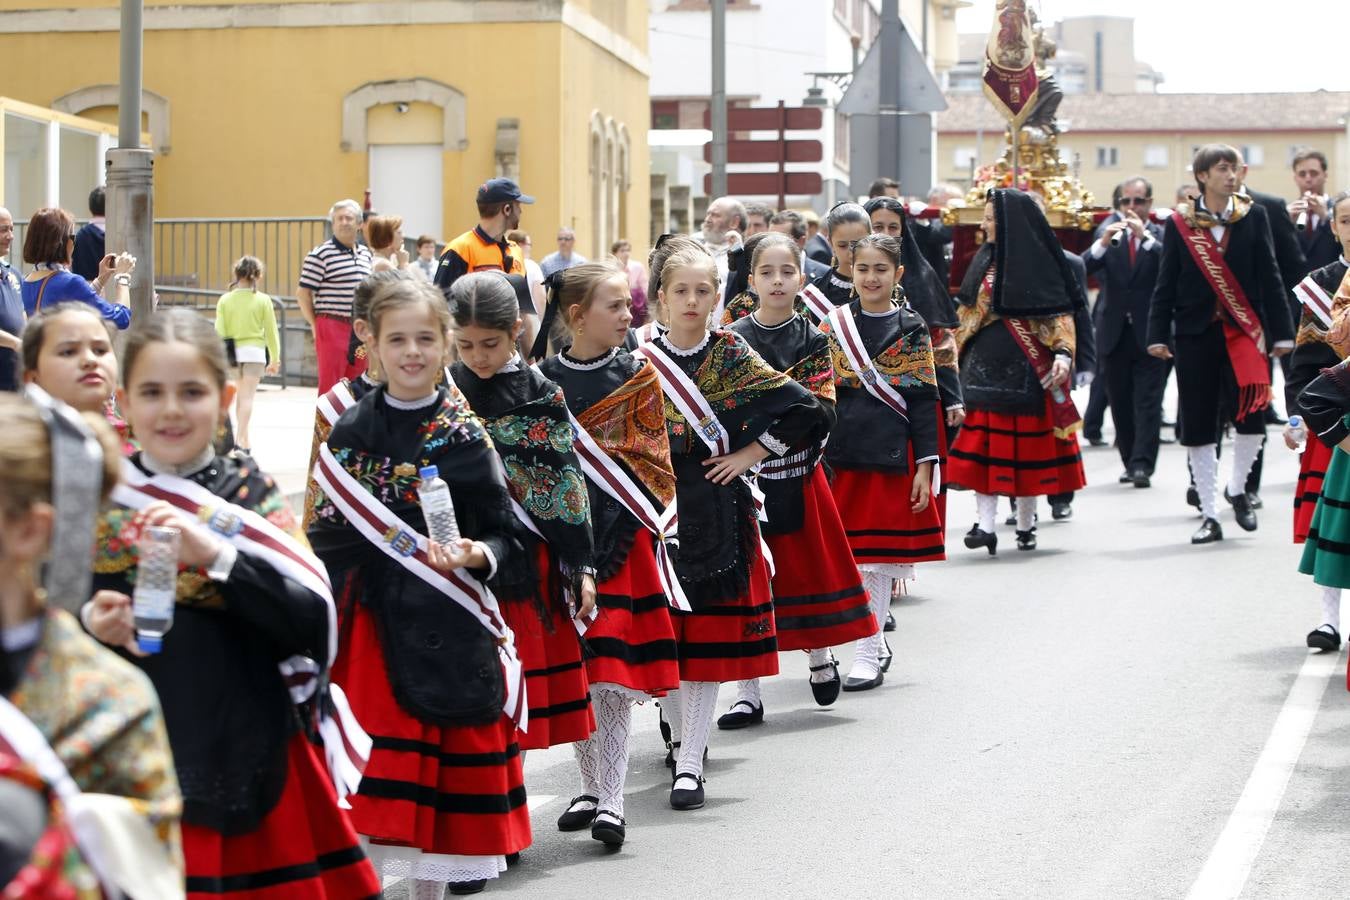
[{"x1": 1148, "y1": 144, "x2": 1293, "y2": 544}]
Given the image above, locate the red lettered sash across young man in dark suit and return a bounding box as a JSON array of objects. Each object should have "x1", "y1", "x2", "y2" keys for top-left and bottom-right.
[{"x1": 1172, "y1": 212, "x2": 1270, "y2": 418}]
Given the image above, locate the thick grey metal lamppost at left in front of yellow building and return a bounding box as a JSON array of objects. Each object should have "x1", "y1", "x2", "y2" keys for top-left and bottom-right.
[{"x1": 107, "y1": 0, "x2": 155, "y2": 320}]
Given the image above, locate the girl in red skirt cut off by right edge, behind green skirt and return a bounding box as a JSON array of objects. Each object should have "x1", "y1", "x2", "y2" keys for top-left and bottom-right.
[{"x1": 1284, "y1": 192, "x2": 1350, "y2": 653}]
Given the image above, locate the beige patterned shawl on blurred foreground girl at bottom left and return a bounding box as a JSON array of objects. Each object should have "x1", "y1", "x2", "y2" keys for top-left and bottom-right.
[{"x1": 9, "y1": 607, "x2": 182, "y2": 865}]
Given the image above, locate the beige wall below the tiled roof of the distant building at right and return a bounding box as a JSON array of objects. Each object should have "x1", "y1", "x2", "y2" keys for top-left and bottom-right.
[{"x1": 937, "y1": 130, "x2": 1350, "y2": 206}]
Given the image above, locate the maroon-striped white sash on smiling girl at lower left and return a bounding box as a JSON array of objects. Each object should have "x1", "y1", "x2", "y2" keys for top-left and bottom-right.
[{"x1": 112, "y1": 464, "x2": 371, "y2": 808}]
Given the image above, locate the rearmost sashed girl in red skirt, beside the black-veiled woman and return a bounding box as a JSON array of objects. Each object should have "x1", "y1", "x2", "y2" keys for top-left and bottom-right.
[{"x1": 821, "y1": 235, "x2": 946, "y2": 691}]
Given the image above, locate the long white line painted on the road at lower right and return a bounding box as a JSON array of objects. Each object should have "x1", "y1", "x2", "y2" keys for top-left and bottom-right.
[{"x1": 1187, "y1": 653, "x2": 1341, "y2": 900}]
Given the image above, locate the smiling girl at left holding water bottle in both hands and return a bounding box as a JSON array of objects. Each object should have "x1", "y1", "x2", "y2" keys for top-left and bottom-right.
[{"x1": 81, "y1": 309, "x2": 379, "y2": 899}]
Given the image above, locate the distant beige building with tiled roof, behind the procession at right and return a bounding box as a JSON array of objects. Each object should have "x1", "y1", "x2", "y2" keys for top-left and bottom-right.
[{"x1": 937, "y1": 90, "x2": 1350, "y2": 206}]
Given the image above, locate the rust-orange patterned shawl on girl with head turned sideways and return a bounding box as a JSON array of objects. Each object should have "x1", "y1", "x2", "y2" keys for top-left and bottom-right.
[{"x1": 576, "y1": 362, "x2": 675, "y2": 506}]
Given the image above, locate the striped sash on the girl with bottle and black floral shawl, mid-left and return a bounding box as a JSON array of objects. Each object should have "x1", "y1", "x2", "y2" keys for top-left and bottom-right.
[{"x1": 313, "y1": 444, "x2": 529, "y2": 731}]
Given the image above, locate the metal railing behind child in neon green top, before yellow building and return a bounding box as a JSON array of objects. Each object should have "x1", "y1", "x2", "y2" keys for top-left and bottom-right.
[{"x1": 11, "y1": 216, "x2": 331, "y2": 385}]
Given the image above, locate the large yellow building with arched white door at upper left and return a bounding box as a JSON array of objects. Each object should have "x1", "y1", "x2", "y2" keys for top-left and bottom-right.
[{"x1": 0, "y1": 0, "x2": 649, "y2": 255}]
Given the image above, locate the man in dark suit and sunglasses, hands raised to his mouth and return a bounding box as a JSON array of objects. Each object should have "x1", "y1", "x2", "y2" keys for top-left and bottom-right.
[{"x1": 1083, "y1": 177, "x2": 1168, "y2": 487}]
